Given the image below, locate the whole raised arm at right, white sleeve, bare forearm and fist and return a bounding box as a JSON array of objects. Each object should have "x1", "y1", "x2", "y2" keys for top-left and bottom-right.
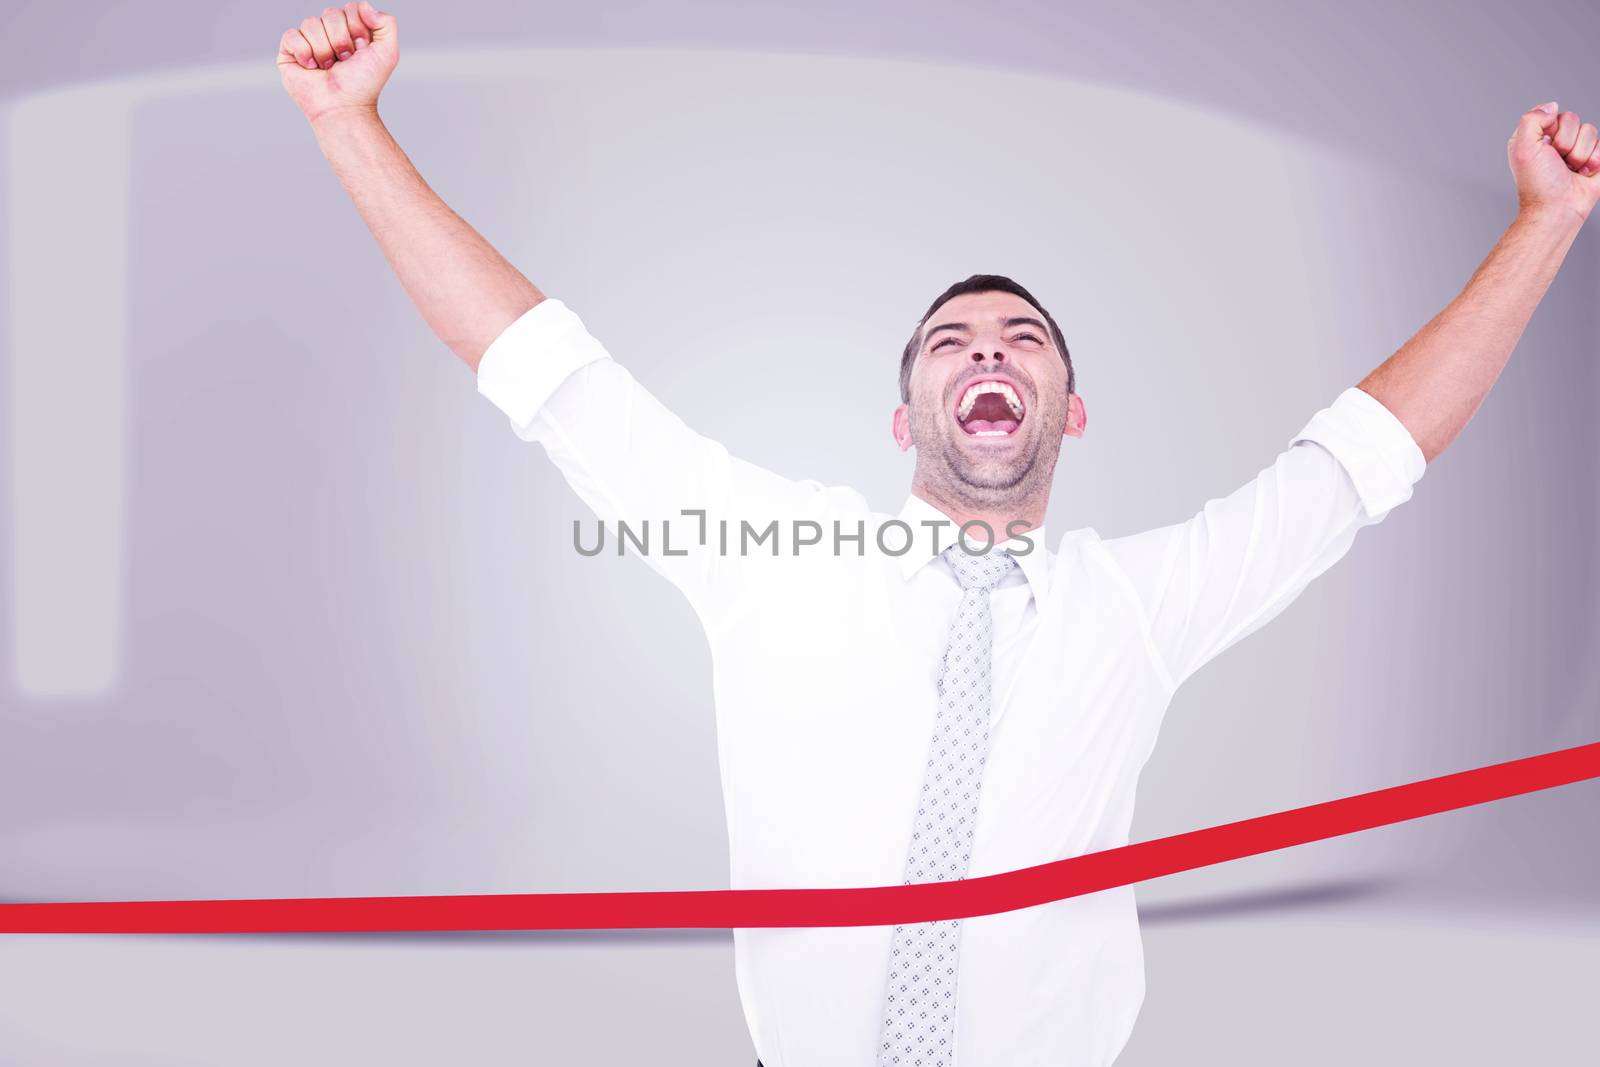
[{"x1": 1102, "y1": 104, "x2": 1600, "y2": 688}]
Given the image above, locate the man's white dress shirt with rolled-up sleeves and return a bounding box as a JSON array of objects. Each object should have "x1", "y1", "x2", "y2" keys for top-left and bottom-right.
[{"x1": 478, "y1": 298, "x2": 1426, "y2": 1067}]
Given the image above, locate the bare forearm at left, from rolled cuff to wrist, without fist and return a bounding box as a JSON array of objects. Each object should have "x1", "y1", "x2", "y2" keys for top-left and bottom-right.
[{"x1": 310, "y1": 107, "x2": 544, "y2": 371}]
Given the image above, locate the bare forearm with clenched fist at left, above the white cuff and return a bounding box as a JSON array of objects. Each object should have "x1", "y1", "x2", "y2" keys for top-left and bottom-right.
[{"x1": 277, "y1": 0, "x2": 544, "y2": 371}]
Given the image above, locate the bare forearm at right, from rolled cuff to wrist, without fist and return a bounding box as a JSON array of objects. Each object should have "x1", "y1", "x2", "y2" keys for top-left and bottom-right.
[{"x1": 1358, "y1": 208, "x2": 1582, "y2": 462}]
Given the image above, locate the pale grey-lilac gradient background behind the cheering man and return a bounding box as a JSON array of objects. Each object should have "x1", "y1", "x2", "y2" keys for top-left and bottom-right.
[{"x1": 0, "y1": 2, "x2": 1600, "y2": 1067}]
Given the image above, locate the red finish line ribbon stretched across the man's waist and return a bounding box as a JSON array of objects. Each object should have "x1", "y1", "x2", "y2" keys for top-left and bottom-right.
[{"x1": 0, "y1": 742, "x2": 1600, "y2": 934}]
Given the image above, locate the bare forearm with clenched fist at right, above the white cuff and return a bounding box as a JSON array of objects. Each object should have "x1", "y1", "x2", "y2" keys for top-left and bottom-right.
[{"x1": 1360, "y1": 101, "x2": 1600, "y2": 462}]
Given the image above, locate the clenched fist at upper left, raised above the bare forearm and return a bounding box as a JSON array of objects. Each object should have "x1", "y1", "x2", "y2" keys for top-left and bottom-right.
[{"x1": 278, "y1": 0, "x2": 400, "y2": 122}]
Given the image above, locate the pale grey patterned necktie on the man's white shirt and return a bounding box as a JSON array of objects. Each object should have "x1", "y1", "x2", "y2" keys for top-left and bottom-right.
[{"x1": 878, "y1": 544, "x2": 1016, "y2": 1067}]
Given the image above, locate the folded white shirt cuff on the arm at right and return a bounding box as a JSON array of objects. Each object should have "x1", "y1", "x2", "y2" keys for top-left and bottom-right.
[{"x1": 1290, "y1": 386, "x2": 1427, "y2": 520}]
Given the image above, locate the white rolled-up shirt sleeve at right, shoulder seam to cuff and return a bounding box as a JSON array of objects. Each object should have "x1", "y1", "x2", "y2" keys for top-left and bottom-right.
[{"x1": 1101, "y1": 387, "x2": 1427, "y2": 688}]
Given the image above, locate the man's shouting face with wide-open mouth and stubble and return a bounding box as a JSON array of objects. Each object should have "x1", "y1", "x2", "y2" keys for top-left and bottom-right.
[{"x1": 894, "y1": 293, "x2": 1086, "y2": 507}]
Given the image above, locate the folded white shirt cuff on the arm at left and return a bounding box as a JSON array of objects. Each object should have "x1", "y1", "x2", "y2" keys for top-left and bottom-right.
[{"x1": 478, "y1": 296, "x2": 611, "y2": 429}]
